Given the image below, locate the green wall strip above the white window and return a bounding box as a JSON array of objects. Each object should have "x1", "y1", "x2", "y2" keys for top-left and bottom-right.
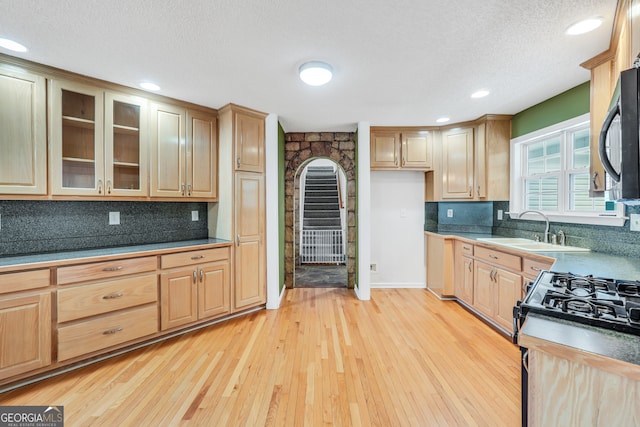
[{"x1": 511, "y1": 81, "x2": 589, "y2": 138}]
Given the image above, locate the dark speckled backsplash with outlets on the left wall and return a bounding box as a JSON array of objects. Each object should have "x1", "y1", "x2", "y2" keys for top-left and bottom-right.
[{"x1": 0, "y1": 200, "x2": 208, "y2": 256}]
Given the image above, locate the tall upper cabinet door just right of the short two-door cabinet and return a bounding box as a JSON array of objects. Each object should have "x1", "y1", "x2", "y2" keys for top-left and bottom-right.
[{"x1": 442, "y1": 128, "x2": 473, "y2": 199}]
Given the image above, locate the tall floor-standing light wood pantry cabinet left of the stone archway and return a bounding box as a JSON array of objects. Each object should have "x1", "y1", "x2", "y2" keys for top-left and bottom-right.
[{"x1": 215, "y1": 104, "x2": 267, "y2": 312}]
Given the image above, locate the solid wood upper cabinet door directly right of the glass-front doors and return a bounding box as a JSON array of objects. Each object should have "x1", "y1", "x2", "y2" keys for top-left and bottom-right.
[{"x1": 151, "y1": 104, "x2": 187, "y2": 197}]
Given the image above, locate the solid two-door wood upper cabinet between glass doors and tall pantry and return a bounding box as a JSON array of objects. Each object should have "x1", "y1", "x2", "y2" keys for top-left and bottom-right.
[{"x1": 151, "y1": 104, "x2": 218, "y2": 201}]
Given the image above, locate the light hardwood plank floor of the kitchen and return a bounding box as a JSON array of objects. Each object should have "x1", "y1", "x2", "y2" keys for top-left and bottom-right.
[{"x1": 0, "y1": 288, "x2": 520, "y2": 426}]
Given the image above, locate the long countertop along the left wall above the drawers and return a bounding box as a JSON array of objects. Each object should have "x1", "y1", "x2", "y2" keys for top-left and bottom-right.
[{"x1": 0, "y1": 239, "x2": 231, "y2": 268}]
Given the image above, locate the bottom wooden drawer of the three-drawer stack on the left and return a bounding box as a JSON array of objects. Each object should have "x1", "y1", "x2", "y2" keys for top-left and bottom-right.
[{"x1": 58, "y1": 305, "x2": 158, "y2": 361}]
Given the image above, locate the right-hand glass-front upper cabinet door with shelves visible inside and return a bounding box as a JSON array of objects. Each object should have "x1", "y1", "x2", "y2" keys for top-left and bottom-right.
[{"x1": 104, "y1": 92, "x2": 149, "y2": 196}]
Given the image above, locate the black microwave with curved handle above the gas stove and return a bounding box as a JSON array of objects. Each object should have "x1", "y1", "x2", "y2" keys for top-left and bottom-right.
[{"x1": 598, "y1": 63, "x2": 640, "y2": 202}]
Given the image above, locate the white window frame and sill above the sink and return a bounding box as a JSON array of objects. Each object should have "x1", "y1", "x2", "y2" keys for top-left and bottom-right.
[{"x1": 509, "y1": 113, "x2": 627, "y2": 227}]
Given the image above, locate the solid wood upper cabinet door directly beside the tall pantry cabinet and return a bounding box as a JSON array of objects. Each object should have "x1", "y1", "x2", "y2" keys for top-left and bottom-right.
[{"x1": 187, "y1": 111, "x2": 218, "y2": 199}]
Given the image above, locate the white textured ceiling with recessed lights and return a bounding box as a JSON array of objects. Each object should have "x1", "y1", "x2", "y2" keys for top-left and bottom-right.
[{"x1": 0, "y1": 0, "x2": 616, "y2": 132}]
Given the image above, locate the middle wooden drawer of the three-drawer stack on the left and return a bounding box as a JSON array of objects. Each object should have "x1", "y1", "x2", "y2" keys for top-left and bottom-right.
[{"x1": 58, "y1": 273, "x2": 158, "y2": 322}]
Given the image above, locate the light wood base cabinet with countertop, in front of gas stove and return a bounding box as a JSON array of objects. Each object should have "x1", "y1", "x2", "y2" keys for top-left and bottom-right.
[{"x1": 518, "y1": 314, "x2": 640, "y2": 427}]
